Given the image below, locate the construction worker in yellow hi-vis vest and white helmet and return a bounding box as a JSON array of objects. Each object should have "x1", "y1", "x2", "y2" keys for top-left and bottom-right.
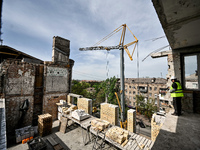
[{"x1": 170, "y1": 76, "x2": 184, "y2": 116}]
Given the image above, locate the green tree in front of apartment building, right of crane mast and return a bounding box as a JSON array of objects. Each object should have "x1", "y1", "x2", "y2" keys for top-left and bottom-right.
[{"x1": 136, "y1": 95, "x2": 157, "y2": 120}]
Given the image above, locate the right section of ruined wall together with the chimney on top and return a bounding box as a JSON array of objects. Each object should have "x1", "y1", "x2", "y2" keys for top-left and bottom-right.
[{"x1": 43, "y1": 36, "x2": 74, "y2": 120}]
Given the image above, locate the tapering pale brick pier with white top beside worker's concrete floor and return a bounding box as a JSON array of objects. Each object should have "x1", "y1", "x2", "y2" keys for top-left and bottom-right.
[{"x1": 151, "y1": 114, "x2": 165, "y2": 142}]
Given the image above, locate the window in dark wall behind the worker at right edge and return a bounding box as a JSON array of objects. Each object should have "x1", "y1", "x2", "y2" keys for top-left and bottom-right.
[{"x1": 183, "y1": 54, "x2": 200, "y2": 89}]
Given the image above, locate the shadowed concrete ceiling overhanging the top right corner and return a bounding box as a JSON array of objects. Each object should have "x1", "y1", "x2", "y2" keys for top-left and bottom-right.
[{"x1": 152, "y1": 0, "x2": 200, "y2": 50}]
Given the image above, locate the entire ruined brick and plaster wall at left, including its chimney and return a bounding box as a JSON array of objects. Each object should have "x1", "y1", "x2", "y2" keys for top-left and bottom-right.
[{"x1": 0, "y1": 37, "x2": 74, "y2": 134}]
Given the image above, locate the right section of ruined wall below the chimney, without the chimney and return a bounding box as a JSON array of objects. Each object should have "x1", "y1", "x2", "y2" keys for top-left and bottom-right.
[{"x1": 43, "y1": 62, "x2": 69, "y2": 120}]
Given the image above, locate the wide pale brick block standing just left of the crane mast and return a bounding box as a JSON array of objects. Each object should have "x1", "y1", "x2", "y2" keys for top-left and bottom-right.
[{"x1": 101, "y1": 103, "x2": 119, "y2": 125}]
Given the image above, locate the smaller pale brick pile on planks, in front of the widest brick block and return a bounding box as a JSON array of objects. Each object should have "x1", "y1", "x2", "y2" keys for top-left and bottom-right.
[{"x1": 91, "y1": 119, "x2": 110, "y2": 131}]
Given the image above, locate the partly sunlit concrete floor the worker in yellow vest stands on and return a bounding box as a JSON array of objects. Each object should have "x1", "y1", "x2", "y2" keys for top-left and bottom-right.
[{"x1": 152, "y1": 110, "x2": 200, "y2": 150}]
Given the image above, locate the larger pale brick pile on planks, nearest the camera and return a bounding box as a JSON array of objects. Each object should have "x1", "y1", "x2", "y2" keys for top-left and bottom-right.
[{"x1": 106, "y1": 127, "x2": 128, "y2": 144}]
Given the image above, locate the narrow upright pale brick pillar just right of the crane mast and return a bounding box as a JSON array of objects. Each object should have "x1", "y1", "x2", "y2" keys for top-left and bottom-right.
[{"x1": 127, "y1": 109, "x2": 136, "y2": 133}]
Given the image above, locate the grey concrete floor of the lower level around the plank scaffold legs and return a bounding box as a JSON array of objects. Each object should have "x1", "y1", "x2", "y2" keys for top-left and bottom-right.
[{"x1": 8, "y1": 120, "x2": 117, "y2": 150}]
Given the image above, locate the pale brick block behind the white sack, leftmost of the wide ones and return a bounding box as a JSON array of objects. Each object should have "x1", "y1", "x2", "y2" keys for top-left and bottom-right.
[{"x1": 77, "y1": 98, "x2": 92, "y2": 115}]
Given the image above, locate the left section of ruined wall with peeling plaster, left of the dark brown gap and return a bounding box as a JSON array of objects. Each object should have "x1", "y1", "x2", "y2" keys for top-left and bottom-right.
[{"x1": 2, "y1": 60, "x2": 35, "y2": 132}]
